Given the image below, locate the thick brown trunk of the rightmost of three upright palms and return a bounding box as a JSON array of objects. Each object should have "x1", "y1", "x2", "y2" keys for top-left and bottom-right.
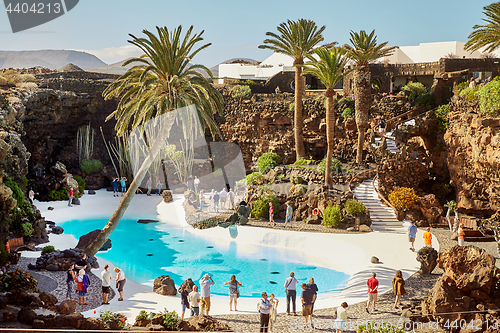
[{"x1": 354, "y1": 66, "x2": 371, "y2": 163}]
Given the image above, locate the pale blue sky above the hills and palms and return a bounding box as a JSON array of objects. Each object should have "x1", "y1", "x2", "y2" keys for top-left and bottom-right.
[{"x1": 0, "y1": 0, "x2": 493, "y2": 67}]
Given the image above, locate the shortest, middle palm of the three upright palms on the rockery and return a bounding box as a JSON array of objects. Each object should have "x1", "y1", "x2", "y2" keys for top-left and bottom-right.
[{"x1": 302, "y1": 47, "x2": 351, "y2": 186}]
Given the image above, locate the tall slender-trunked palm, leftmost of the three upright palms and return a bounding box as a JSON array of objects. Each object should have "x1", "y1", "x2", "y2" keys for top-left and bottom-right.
[{"x1": 259, "y1": 19, "x2": 326, "y2": 160}]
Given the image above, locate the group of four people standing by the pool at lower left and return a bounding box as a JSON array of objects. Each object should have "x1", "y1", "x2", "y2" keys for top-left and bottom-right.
[{"x1": 66, "y1": 253, "x2": 126, "y2": 305}]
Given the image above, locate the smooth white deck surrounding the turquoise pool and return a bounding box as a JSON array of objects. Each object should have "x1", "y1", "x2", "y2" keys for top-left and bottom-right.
[{"x1": 23, "y1": 190, "x2": 439, "y2": 323}]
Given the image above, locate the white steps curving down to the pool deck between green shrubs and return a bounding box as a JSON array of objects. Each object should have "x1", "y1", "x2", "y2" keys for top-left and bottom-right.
[{"x1": 353, "y1": 179, "x2": 405, "y2": 233}]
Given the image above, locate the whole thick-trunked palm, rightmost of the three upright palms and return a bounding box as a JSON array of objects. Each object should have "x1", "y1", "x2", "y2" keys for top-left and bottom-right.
[{"x1": 345, "y1": 30, "x2": 395, "y2": 163}]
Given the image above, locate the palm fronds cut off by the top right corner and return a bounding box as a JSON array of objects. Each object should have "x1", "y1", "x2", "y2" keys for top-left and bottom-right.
[{"x1": 464, "y1": 2, "x2": 500, "y2": 52}]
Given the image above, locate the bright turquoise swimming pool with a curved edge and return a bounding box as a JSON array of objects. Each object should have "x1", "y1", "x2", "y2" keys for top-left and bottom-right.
[{"x1": 60, "y1": 216, "x2": 350, "y2": 297}]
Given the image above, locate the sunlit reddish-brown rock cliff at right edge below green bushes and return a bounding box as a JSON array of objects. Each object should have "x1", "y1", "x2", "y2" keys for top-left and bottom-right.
[{"x1": 444, "y1": 100, "x2": 500, "y2": 214}]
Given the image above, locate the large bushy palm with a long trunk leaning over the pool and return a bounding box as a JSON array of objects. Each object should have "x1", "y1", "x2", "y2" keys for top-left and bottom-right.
[{"x1": 85, "y1": 26, "x2": 222, "y2": 255}]
